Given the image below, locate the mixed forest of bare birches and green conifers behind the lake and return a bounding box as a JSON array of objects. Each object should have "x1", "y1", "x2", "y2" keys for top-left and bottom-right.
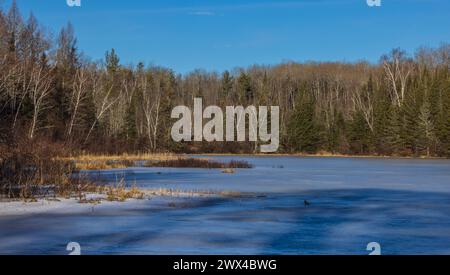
[{"x1": 0, "y1": 2, "x2": 450, "y2": 156}]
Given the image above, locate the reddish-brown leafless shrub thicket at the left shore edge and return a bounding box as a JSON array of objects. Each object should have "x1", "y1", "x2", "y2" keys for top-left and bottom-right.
[{"x1": 0, "y1": 138, "x2": 99, "y2": 200}]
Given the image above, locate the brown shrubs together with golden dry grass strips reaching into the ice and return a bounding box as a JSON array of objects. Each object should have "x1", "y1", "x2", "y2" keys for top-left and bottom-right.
[{"x1": 0, "y1": 136, "x2": 243, "y2": 204}]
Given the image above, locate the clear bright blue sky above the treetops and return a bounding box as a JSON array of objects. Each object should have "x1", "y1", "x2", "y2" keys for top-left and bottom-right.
[{"x1": 0, "y1": 0, "x2": 450, "y2": 73}]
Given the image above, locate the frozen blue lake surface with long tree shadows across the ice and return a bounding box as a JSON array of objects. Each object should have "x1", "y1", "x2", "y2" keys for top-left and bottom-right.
[{"x1": 0, "y1": 157, "x2": 450, "y2": 254}]
